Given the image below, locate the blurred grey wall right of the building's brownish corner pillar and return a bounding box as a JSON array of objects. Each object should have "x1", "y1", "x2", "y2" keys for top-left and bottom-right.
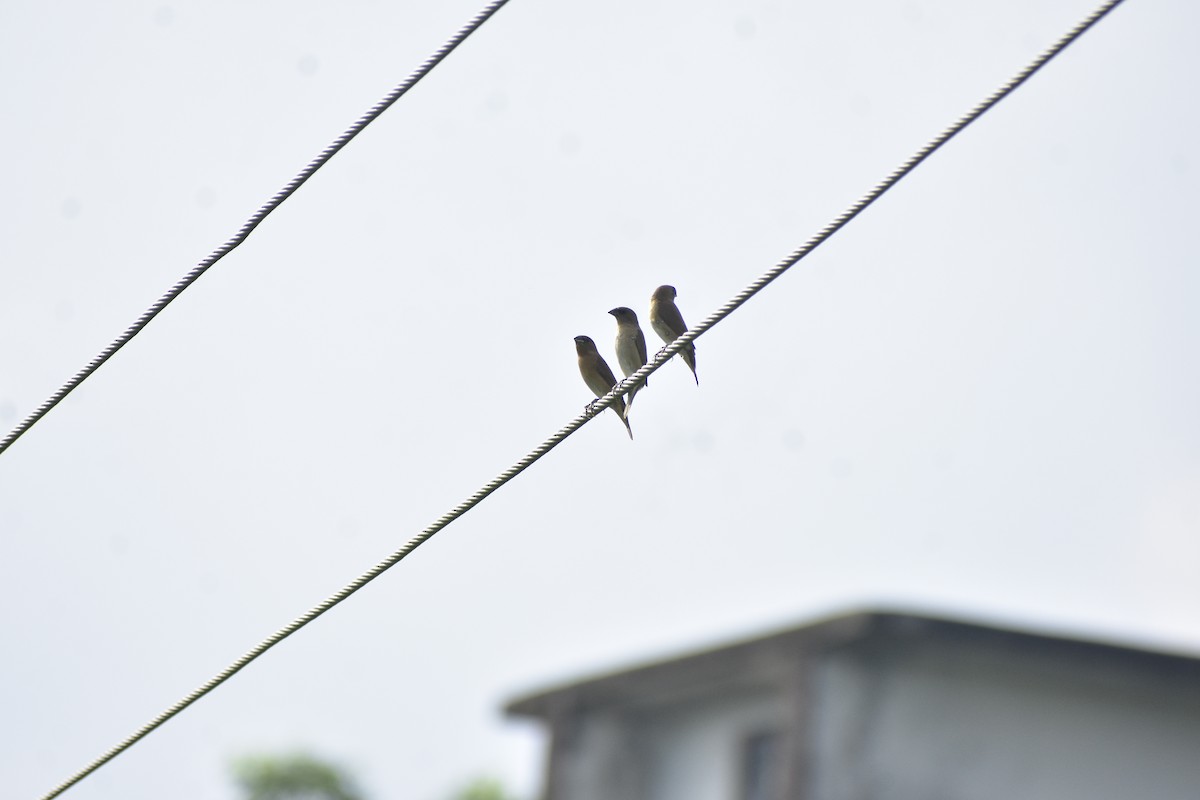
[{"x1": 812, "y1": 645, "x2": 1200, "y2": 800}]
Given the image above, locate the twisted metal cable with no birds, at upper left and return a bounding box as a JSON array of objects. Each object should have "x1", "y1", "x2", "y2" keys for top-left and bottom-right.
[{"x1": 0, "y1": 0, "x2": 509, "y2": 453}]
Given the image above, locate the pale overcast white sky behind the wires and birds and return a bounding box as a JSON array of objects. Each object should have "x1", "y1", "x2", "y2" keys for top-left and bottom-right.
[{"x1": 0, "y1": 0, "x2": 1200, "y2": 800}]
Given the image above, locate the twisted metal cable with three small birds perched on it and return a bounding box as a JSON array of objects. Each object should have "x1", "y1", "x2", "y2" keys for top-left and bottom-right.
[{"x1": 42, "y1": 0, "x2": 1123, "y2": 800}]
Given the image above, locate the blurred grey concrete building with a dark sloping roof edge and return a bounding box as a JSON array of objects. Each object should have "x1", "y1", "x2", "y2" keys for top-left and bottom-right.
[{"x1": 506, "y1": 613, "x2": 1200, "y2": 800}]
